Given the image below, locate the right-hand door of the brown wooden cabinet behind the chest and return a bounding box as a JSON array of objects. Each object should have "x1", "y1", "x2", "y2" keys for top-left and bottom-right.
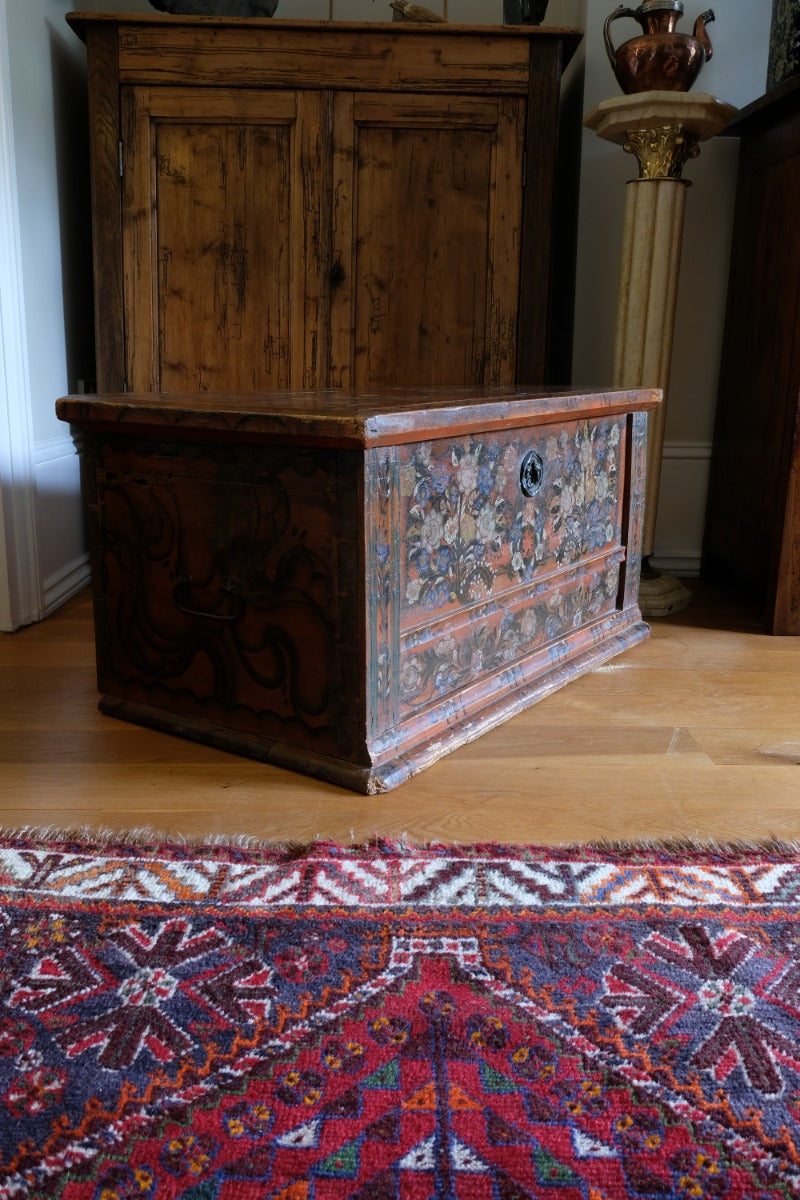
[{"x1": 331, "y1": 94, "x2": 524, "y2": 388}]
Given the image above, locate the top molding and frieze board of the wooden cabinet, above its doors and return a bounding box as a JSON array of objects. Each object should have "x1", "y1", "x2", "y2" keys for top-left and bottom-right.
[{"x1": 66, "y1": 13, "x2": 583, "y2": 95}]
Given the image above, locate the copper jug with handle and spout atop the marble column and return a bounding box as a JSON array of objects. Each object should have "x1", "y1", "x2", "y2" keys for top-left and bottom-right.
[{"x1": 603, "y1": 0, "x2": 714, "y2": 95}]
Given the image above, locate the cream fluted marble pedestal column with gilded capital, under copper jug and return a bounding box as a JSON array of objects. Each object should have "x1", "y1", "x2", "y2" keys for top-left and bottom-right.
[{"x1": 584, "y1": 91, "x2": 736, "y2": 617}]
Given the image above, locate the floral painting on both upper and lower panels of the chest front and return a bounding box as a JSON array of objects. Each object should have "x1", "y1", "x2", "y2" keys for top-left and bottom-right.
[{"x1": 399, "y1": 419, "x2": 622, "y2": 709}]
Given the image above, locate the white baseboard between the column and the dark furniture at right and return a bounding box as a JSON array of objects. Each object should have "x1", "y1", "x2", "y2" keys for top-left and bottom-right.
[{"x1": 652, "y1": 442, "x2": 712, "y2": 578}]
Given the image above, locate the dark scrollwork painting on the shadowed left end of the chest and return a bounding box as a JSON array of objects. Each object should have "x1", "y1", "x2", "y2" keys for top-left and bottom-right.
[{"x1": 98, "y1": 446, "x2": 336, "y2": 732}]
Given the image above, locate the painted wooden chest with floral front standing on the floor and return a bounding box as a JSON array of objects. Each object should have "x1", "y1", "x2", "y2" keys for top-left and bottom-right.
[{"x1": 58, "y1": 389, "x2": 658, "y2": 792}]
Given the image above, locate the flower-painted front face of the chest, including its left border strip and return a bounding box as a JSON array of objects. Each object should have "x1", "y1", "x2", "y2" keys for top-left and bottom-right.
[{"x1": 367, "y1": 416, "x2": 640, "y2": 736}]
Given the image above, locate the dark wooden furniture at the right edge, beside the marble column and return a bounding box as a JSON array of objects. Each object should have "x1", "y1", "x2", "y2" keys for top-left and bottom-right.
[{"x1": 703, "y1": 78, "x2": 800, "y2": 634}]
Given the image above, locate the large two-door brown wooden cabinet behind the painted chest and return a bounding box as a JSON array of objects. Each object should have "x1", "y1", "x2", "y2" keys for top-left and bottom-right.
[{"x1": 68, "y1": 14, "x2": 579, "y2": 391}]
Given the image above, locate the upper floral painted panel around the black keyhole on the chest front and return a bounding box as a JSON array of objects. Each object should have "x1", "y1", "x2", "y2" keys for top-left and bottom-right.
[{"x1": 401, "y1": 420, "x2": 620, "y2": 613}]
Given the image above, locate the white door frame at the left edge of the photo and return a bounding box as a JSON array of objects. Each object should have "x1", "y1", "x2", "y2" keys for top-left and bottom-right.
[{"x1": 0, "y1": 0, "x2": 43, "y2": 630}]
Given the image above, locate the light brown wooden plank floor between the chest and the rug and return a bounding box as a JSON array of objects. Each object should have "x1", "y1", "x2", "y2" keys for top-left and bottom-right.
[{"x1": 0, "y1": 582, "x2": 800, "y2": 844}]
